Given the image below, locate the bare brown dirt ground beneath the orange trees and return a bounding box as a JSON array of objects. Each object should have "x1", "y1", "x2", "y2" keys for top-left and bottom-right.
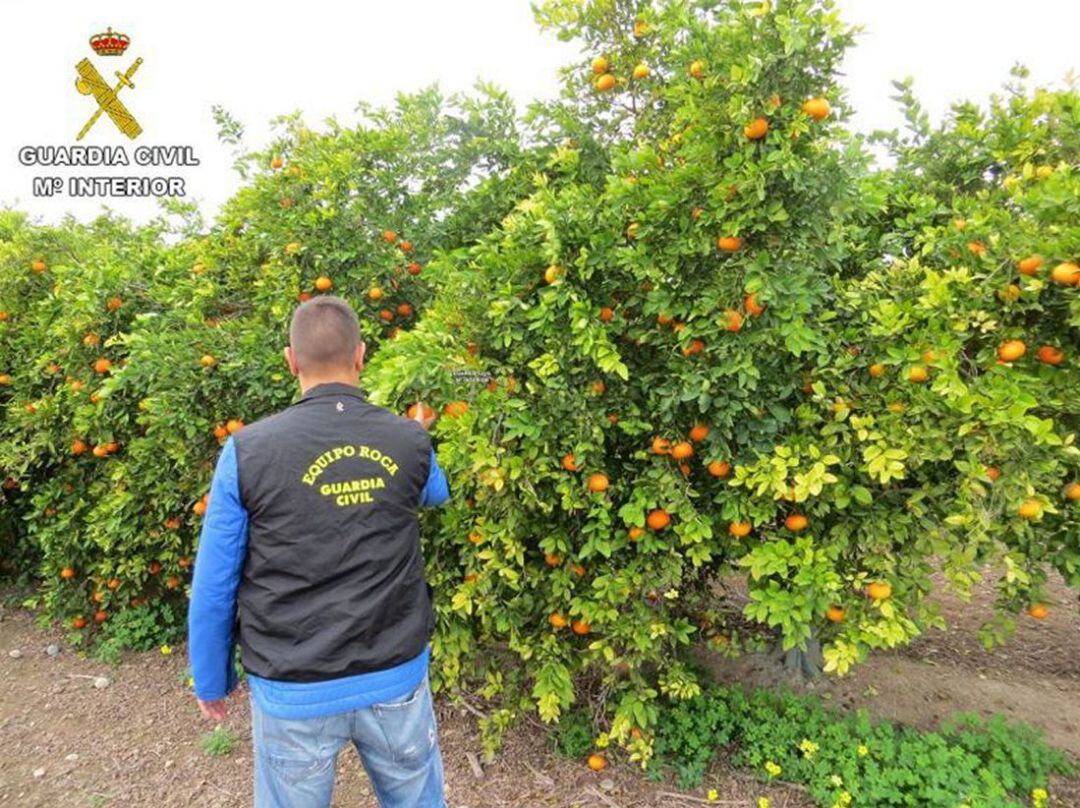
[{"x1": 0, "y1": 570, "x2": 1080, "y2": 808}]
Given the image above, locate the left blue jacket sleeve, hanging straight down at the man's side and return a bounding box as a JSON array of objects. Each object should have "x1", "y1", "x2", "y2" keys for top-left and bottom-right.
[{"x1": 188, "y1": 437, "x2": 247, "y2": 701}]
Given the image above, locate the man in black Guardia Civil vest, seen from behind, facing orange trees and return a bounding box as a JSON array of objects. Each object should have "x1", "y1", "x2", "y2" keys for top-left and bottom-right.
[{"x1": 188, "y1": 297, "x2": 448, "y2": 808}]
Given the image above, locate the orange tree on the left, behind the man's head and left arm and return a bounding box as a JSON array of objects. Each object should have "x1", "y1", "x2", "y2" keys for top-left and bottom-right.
[{"x1": 0, "y1": 87, "x2": 529, "y2": 646}]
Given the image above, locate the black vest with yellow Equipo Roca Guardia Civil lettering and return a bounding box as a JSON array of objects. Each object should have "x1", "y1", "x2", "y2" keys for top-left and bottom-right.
[{"x1": 233, "y1": 385, "x2": 434, "y2": 682}]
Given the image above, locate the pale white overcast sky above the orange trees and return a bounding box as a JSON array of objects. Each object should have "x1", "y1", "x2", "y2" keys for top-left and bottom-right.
[{"x1": 0, "y1": 0, "x2": 1080, "y2": 221}]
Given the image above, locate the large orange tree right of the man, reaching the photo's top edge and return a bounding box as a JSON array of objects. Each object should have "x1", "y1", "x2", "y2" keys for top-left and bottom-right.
[{"x1": 368, "y1": 2, "x2": 1080, "y2": 758}]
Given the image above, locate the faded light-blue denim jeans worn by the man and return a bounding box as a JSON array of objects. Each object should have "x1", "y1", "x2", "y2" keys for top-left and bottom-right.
[{"x1": 252, "y1": 676, "x2": 446, "y2": 808}]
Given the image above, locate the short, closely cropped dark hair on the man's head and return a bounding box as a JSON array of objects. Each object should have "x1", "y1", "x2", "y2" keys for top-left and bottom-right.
[{"x1": 288, "y1": 296, "x2": 360, "y2": 372}]
